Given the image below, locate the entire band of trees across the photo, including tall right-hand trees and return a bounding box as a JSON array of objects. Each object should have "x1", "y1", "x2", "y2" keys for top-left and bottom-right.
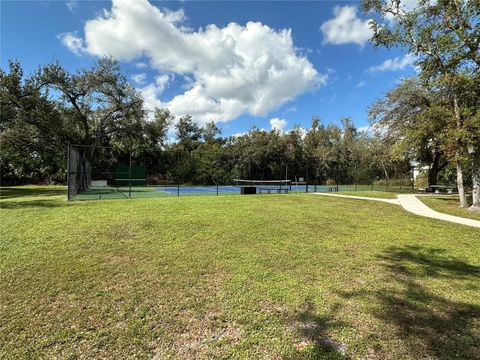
[{"x1": 0, "y1": 0, "x2": 480, "y2": 208}]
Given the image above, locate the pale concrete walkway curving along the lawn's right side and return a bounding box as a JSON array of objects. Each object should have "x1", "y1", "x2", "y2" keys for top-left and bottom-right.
[{"x1": 313, "y1": 193, "x2": 480, "y2": 228}]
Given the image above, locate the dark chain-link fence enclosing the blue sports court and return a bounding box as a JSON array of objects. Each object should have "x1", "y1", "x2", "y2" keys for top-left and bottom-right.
[{"x1": 67, "y1": 145, "x2": 412, "y2": 200}]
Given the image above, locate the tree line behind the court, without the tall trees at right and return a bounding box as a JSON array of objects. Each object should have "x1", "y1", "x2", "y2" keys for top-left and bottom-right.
[{"x1": 0, "y1": 57, "x2": 409, "y2": 188}]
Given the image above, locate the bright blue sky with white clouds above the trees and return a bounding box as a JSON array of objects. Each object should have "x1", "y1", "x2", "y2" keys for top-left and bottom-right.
[{"x1": 1, "y1": 0, "x2": 414, "y2": 135}]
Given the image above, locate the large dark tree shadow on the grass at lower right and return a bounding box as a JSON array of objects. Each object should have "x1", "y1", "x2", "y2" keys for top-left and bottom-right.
[{"x1": 342, "y1": 246, "x2": 480, "y2": 359}]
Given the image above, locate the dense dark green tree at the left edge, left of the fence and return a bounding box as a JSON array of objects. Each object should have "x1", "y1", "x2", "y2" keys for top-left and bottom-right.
[{"x1": 0, "y1": 61, "x2": 69, "y2": 184}]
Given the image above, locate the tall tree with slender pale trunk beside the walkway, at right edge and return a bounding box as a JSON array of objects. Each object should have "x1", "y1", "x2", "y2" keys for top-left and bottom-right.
[{"x1": 363, "y1": 0, "x2": 480, "y2": 207}]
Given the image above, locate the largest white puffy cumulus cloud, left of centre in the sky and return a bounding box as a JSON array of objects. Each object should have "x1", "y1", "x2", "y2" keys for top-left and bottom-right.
[{"x1": 59, "y1": 0, "x2": 322, "y2": 122}]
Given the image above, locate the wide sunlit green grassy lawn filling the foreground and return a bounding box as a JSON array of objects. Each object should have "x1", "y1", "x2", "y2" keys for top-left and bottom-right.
[{"x1": 0, "y1": 187, "x2": 480, "y2": 359}]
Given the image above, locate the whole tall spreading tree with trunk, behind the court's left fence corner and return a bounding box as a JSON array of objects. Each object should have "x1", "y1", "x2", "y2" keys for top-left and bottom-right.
[{"x1": 35, "y1": 57, "x2": 146, "y2": 190}]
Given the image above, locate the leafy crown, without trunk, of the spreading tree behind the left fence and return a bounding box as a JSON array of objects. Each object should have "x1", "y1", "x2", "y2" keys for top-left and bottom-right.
[{"x1": 36, "y1": 57, "x2": 146, "y2": 145}]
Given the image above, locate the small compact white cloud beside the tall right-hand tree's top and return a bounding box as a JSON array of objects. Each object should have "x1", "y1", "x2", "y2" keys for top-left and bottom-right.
[{"x1": 320, "y1": 5, "x2": 373, "y2": 46}]
